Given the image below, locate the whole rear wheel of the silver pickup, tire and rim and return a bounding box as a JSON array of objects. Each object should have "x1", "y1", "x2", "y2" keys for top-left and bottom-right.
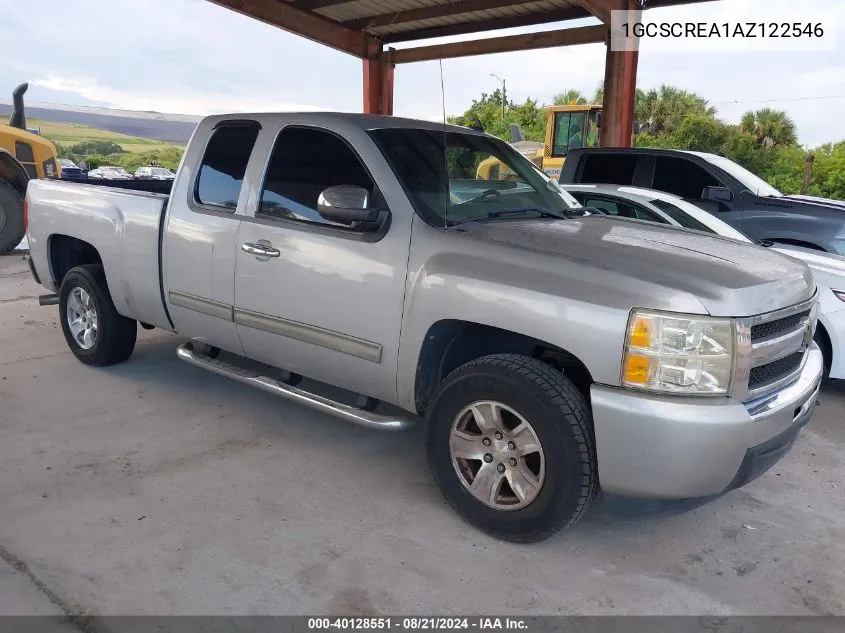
[{"x1": 59, "y1": 264, "x2": 138, "y2": 367}]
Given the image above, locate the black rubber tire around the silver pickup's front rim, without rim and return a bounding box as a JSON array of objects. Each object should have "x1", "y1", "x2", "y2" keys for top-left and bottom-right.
[{"x1": 426, "y1": 354, "x2": 598, "y2": 543}]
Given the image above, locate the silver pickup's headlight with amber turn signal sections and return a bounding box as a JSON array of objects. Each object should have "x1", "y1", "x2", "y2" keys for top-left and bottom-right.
[{"x1": 621, "y1": 310, "x2": 734, "y2": 395}]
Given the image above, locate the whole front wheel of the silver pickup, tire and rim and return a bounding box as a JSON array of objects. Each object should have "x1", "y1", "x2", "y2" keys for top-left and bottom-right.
[{"x1": 426, "y1": 354, "x2": 598, "y2": 543}]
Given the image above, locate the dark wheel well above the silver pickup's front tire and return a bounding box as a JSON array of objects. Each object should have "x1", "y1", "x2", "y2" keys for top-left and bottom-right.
[{"x1": 414, "y1": 319, "x2": 593, "y2": 414}]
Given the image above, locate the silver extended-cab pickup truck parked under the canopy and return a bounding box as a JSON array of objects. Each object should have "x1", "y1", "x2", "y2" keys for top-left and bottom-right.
[{"x1": 26, "y1": 114, "x2": 822, "y2": 542}]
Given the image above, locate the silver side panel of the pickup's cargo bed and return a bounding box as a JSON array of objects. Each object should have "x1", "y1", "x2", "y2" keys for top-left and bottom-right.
[{"x1": 27, "y1": 180, "x2": 172, "y2": 330}]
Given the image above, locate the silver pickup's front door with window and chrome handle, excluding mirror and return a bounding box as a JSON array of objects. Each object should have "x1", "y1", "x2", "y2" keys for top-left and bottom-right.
[{"x1": 235, "y1": 124, "x2": 411, "y2": 401}]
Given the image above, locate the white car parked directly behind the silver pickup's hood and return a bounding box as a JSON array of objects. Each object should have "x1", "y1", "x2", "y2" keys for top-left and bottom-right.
[{"x1": 561, "y1": 185, "x2": 845, "y2": 379}]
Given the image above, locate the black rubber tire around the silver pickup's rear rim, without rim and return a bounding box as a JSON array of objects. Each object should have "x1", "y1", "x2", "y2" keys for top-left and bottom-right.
[{"x1": 59, "y1": 264, "x2": 138, "y2": 367}]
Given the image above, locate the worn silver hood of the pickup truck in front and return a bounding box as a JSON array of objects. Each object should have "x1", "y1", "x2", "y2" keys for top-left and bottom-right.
[{"x1": 461, "y1": 215, "x2": 816, "y2": 317}]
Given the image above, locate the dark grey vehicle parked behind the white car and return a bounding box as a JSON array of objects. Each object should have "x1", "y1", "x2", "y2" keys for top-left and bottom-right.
[{"x1": 560, "y1": 148, "x2": 845, "y2": 255}]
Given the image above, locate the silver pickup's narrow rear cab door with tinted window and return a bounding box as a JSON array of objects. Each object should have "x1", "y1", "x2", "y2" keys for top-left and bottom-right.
[{"x1": 162, "y1": 120, "x2": 261, "y2": 354}]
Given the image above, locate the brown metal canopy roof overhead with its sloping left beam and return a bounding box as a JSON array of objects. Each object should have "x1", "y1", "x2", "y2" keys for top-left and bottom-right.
[{"x1": 209, "y1": 0, "x2": 707, "y2": 58}]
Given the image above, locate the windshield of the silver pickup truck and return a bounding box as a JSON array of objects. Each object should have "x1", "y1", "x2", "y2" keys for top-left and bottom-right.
[{"x1": 370, "y1": 128, "x2": 582, "y2": 226}]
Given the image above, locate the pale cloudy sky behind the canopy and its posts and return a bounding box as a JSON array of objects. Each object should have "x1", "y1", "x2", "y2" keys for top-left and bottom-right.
[{"x1": 0, "y1": 0, "x2": 845, "y2": 146}]
